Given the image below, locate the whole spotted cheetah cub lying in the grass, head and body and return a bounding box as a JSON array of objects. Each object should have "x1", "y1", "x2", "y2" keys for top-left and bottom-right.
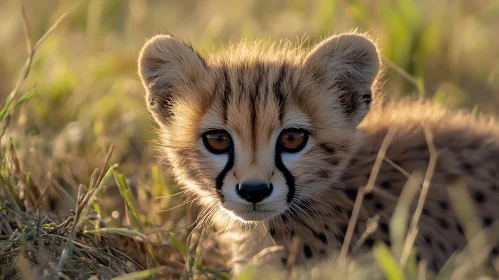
[{"x1": 139, "y1": 34, "x2": 499, "y2": 270}]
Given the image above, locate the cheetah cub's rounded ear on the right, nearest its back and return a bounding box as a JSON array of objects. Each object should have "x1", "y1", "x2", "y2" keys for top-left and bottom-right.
[{"x1": 304, "y1": 34, "x2": 380, "y2": 126}]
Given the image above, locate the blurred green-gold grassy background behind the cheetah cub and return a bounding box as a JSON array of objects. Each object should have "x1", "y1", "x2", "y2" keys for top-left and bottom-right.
[{"x1": 0, "y1": 0, "x2": 499, "y2": 224}]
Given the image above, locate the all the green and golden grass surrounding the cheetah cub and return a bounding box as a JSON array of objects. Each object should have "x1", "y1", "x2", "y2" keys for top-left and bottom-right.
[{"x1": 0, "y1": 0, "x2": 499, "y2": 279}]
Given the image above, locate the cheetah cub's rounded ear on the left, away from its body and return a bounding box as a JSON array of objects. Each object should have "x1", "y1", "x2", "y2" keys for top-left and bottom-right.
[{"x1": 139, "y1": 35, "x2": 208, "y2": 125}]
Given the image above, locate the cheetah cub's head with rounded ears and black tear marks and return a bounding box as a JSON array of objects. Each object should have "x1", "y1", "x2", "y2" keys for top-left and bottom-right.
[{"x1": 139, "y1": 34, "x2": 380, "y2": 221}]
